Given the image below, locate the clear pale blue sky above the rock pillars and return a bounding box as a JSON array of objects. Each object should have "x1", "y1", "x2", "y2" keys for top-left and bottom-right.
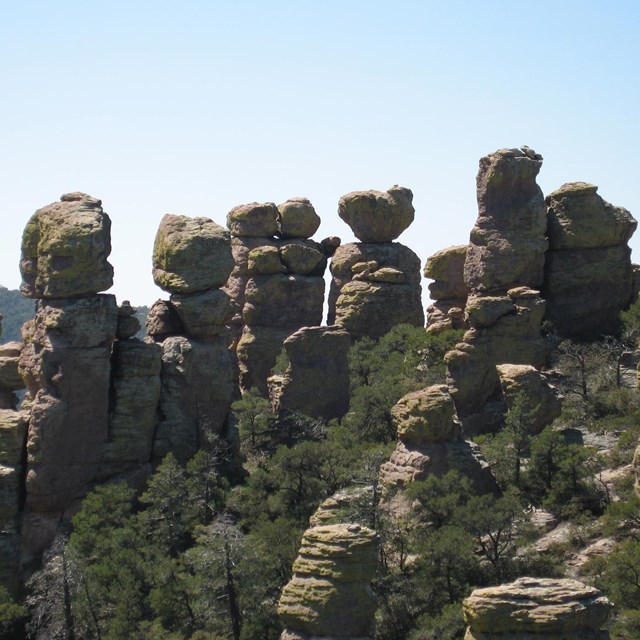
[{"x1": 0, "y1": 0, "x2": 640, "y2": 304}]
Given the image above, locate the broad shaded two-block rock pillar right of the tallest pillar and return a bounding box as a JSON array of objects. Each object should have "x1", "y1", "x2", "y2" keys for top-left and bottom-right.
[{"x1": 542, "y1": 182, "x2": 638, "y2": 340}]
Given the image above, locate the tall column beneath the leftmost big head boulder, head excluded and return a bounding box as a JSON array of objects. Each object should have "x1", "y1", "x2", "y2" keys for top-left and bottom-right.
[{"x1": 20, "y1": 295, "x2": 117, "y2": 511}]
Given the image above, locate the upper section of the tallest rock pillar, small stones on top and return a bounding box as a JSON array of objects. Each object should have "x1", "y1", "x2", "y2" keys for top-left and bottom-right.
[{"x1": 464, "y1": 149, "x2": 547, "y2": 291}]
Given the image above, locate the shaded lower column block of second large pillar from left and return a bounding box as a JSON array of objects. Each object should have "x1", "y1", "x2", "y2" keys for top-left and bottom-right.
[{"x1": 153, "y1": 336, "x2": 233, "y2": 463}]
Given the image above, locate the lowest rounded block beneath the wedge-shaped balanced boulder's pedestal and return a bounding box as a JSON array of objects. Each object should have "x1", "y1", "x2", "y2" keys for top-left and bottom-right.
[{"x1": 335, "y1": 280, "x2": 424, "y2": 338}]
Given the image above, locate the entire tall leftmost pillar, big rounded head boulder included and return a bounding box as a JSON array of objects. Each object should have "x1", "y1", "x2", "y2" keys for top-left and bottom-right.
[{"x1": 20, "y1": 193, "x2": 118, "y2": 552}]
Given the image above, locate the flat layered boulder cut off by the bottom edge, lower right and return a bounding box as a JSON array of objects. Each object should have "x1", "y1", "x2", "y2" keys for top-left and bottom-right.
[{"x1": 462, "y1": 578, "x2": 613, "y2": 640}]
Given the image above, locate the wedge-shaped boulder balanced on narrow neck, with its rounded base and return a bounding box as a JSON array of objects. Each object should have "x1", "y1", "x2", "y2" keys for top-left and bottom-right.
[{"x1": 328, "y1": 186, "x2": 424, "y2": 339}]
